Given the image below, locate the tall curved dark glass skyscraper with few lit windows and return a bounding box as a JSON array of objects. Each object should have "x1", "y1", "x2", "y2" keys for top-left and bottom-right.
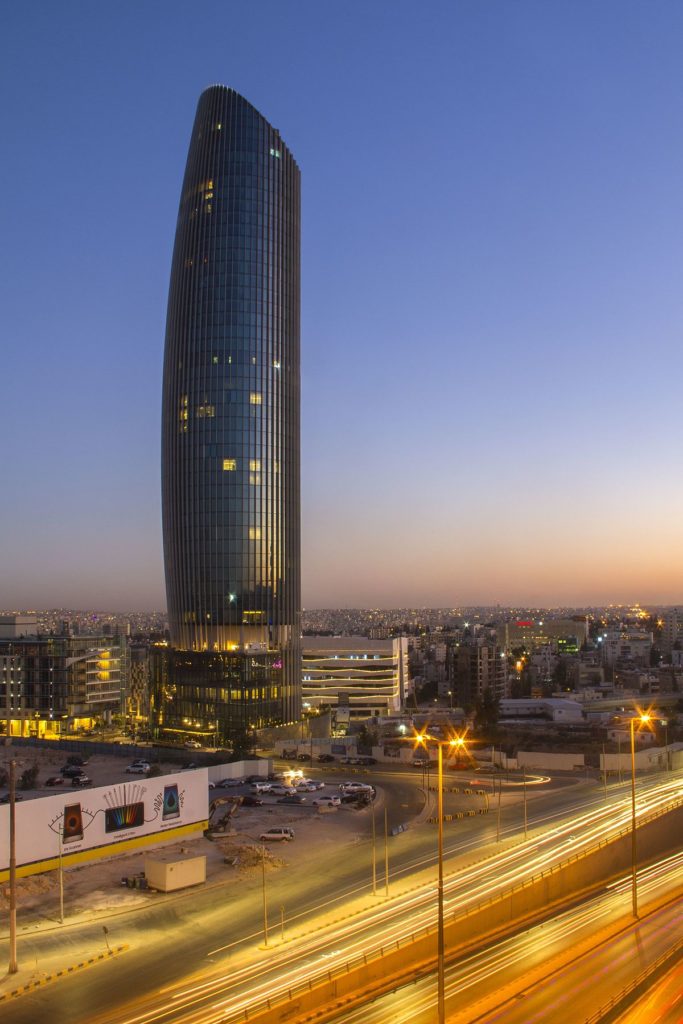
[{"x1": 155, "y1": 86, "x2": 300, "y2": 735}]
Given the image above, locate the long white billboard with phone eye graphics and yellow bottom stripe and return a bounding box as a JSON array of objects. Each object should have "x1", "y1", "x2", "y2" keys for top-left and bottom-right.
[{"x1": 0, "y1": 768, "x2": 209, "y2": 882}]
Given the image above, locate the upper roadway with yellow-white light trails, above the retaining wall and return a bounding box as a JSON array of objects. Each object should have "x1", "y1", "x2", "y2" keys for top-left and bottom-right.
[{"x1": 3, "y1": 773, "x2": 682, "y2": 1024}]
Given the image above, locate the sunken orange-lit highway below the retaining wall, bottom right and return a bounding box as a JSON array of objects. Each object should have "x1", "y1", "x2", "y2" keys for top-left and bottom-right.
[{"x1": 325, "y1": 854, "x2": 683, "y2": 1024}]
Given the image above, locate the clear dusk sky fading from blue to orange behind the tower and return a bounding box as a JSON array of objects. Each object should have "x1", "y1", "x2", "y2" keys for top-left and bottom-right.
[{"x1": 0, "y1": 0, "x2": 683, "y2": 608}]
